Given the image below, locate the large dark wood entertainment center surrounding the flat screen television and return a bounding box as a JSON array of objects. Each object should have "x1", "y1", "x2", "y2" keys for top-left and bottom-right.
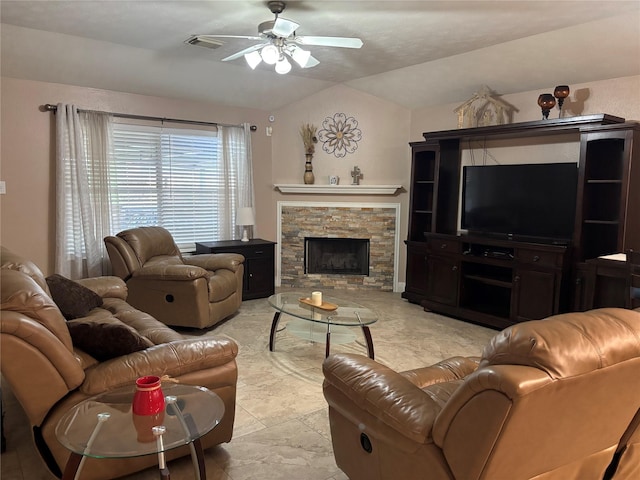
[{"x1": 402, "y1": 114, "x2": 640, "y2": 328}]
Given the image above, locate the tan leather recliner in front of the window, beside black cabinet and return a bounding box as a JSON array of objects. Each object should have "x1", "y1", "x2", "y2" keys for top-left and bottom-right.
[{"x1": 104, "y1": 227, "x2": 244, "y2": 328}]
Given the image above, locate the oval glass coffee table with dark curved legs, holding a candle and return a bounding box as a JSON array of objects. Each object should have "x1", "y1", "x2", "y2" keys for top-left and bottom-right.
[{"x1": 268, "y1": 292, "x2": 378, "y2": 359}]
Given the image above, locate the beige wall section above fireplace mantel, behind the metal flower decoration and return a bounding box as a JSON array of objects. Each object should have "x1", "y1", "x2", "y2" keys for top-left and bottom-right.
[{"x1": 272, "y1": 85, "x2": 411, "y2": 282}]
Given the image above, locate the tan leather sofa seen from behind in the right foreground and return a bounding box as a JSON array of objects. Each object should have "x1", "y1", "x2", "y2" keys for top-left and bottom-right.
[{"x1": 323, "y1": 308, "x2": 640, "y2": 480}]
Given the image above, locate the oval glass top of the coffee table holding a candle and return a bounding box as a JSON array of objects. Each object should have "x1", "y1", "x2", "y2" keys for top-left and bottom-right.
[{"x1": 267, "y1": 292, "x2": 378, "y2": 326}]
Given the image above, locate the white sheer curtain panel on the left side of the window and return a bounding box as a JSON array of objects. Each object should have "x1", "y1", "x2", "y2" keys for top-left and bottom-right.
[{"x1": 55, "y1": 104, "x2": 111, "y2": 279}]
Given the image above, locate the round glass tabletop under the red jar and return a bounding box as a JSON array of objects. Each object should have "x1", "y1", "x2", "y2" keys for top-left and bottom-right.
[{"x1": 56, "y1": 384, "x2": 224, "y2": 458}]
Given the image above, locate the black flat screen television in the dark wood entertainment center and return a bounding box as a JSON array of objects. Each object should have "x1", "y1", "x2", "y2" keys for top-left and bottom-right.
[{"x1": 461, "y1": 163, "x2": 578, "y2": 243}]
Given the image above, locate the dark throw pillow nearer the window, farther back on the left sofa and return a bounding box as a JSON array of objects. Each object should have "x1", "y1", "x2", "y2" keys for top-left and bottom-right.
[{"x1": 47, "y1": 273, "x2": 102, "y2": 320}]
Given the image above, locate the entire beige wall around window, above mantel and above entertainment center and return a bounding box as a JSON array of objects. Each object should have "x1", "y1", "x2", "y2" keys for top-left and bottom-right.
[{"x1": 0, "y1": 76, "x2": 640, "y2": 281}]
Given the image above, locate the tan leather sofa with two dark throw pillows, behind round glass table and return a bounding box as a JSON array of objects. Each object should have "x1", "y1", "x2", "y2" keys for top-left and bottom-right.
[{"x1": 0, "y1": 248, "x2": 238, "y2": 480}]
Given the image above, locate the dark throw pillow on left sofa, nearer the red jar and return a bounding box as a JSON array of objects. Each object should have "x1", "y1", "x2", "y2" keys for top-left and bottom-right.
[{"x1": 67, "y1": 317, "x2": 153, "y2": 361}]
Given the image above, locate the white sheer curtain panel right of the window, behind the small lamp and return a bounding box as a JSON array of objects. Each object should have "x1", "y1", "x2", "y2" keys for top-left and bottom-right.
[{"x1": 218, "y1": 123, "x2": 257, "y2": 238}]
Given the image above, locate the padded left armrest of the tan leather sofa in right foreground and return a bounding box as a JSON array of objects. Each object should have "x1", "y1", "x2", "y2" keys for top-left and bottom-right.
[{"x1": 322, "y1": 354, "x2": 440, "y2": 444}]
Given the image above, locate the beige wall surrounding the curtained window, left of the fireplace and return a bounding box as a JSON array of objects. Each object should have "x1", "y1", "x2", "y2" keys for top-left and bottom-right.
[{"x1": 0, "y1": 77, "x2": 273, "y2": 274}]
